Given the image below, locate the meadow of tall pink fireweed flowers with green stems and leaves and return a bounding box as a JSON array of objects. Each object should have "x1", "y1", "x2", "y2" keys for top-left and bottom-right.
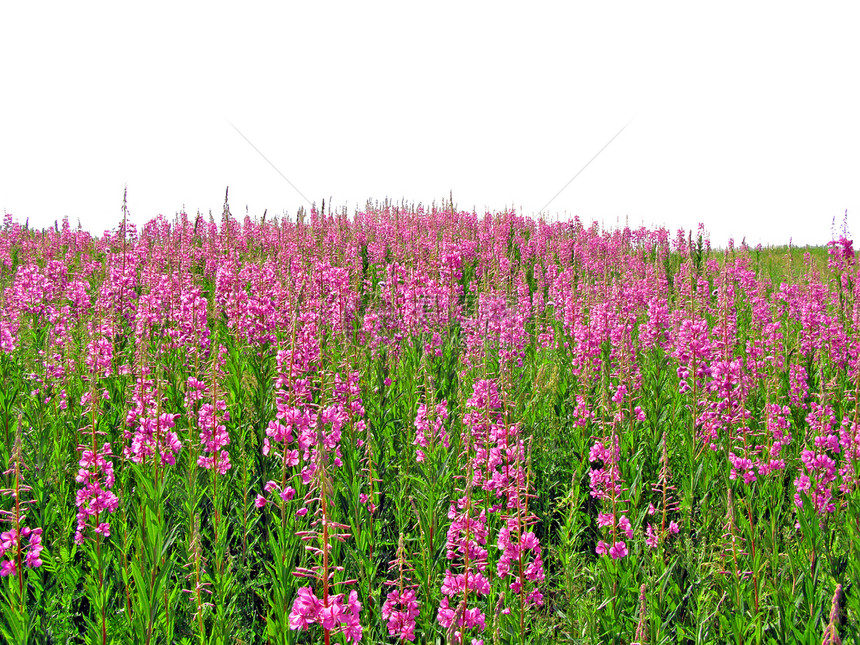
[{"x1": 0, "y1": 197, "x2": 860, "y2": 645}]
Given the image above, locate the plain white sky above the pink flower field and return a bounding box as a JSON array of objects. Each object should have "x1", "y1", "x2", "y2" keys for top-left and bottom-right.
[{"x1": 0, "y1": 0, "x2": 860, "y2": 245}]
